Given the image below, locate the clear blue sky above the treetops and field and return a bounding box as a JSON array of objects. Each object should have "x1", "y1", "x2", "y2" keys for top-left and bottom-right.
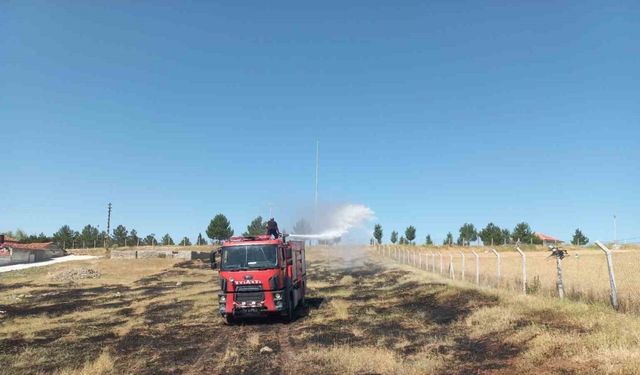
[{"x1": 0, "y1": 1, "x2": 640, "y2": 242}]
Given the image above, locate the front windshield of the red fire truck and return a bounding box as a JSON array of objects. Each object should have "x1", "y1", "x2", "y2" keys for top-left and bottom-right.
[{"x1": 220, "y1": 245, "x2": 278, "y2": 270}]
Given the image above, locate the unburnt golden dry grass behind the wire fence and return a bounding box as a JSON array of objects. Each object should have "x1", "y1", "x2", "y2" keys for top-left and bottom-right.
[{"x1": 384, "y1": 246, "x2": 640, "y2": 313}]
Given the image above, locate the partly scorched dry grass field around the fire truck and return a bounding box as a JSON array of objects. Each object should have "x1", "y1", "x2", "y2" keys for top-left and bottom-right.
[{"x1": 0, "y1": 248, "x2": 640, "y2": 374}]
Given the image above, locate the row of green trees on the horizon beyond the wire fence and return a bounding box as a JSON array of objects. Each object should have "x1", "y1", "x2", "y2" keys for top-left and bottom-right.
[{"x1": 371, "y1": 222, "x2": 589, "y2": 246}]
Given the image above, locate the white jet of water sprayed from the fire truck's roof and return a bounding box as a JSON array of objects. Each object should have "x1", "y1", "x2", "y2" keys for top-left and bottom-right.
[{"x1": 291, "y1": 204, "x2": 375, "y2": 240}]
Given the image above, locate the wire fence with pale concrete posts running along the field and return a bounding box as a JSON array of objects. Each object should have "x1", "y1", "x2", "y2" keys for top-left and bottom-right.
[{"x1": 373, "y1": 244, "x2": 640, "y2": 313}]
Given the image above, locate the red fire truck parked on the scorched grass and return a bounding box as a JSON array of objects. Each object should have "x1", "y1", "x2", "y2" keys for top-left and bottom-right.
[{"x1": 212, "y1": 235, "x2": 307, "y2": 324}]
